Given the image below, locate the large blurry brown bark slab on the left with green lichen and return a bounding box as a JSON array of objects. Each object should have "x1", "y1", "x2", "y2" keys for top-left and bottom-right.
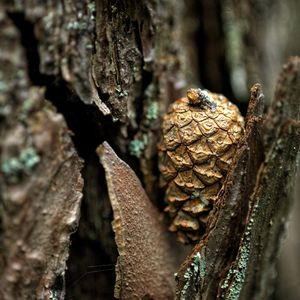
[{"x1": 0, "y1": 8, "x2": 83, "y2": 300}]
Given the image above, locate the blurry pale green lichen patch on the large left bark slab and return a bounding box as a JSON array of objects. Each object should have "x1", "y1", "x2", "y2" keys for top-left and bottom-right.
[{"x1": 1, "y1": 147, "x2": 40, "y2": 183}]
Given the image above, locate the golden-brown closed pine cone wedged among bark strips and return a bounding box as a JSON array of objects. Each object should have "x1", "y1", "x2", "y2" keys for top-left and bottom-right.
[{"x1": 159, "y1": 89, "x2": 243, "y2": 243}]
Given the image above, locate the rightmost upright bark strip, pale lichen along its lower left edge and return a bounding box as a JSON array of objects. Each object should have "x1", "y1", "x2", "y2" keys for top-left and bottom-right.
[{"x1": 221, "y1": 122, "x2": 300, "y2": 300}]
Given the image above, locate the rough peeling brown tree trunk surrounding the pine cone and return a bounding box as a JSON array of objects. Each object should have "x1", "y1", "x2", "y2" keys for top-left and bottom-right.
[{"x1": 0, "y1": 0, "x2": 300, "y2": 300}]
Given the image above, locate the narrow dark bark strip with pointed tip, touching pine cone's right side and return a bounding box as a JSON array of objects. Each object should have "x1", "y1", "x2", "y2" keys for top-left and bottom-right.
[{"x1": 177, "y1": 85, "x2": 263, "y2": 299}]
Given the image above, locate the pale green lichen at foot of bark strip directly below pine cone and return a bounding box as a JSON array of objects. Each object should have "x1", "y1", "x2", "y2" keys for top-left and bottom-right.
[{"x1": 180, "y1": 252, "x2": 206, "y2": 300}]
